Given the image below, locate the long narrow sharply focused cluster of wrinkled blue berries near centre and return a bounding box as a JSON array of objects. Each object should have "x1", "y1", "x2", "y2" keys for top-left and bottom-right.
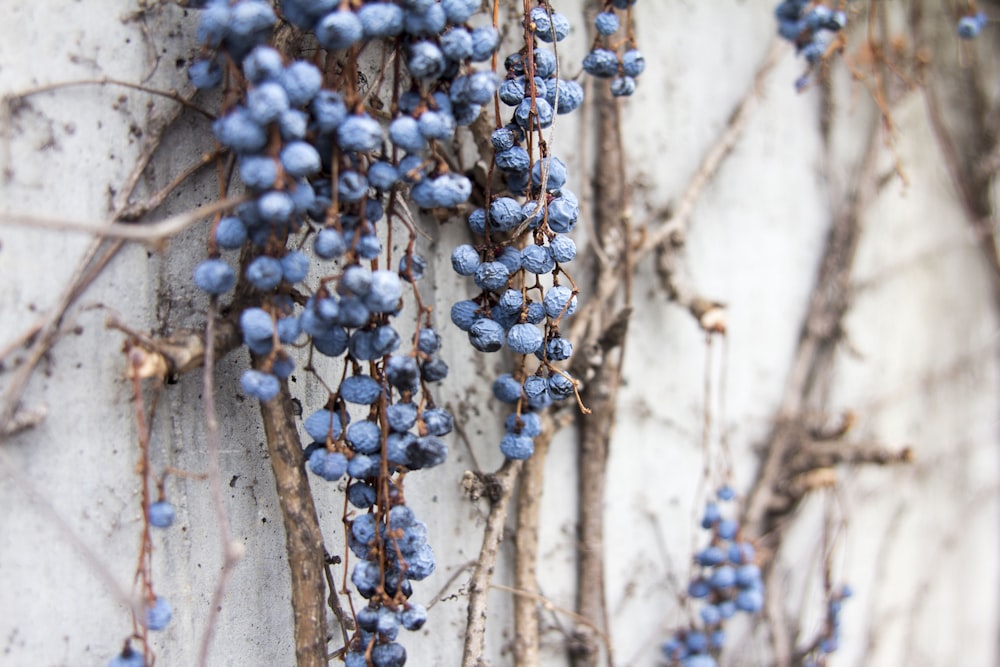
[{"x1": 451, "y1": 1, "x2": 583, "y2": 459}]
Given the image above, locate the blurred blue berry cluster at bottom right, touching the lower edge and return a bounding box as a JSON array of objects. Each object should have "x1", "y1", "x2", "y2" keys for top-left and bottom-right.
[{"x1": 663, "y1": 486, "x2": 764, "y2": 667}]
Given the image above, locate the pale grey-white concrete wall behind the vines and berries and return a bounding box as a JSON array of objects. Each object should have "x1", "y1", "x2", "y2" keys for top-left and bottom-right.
[{"x1": 0, "y1": 0, "x2": 1000, "y2": 667}]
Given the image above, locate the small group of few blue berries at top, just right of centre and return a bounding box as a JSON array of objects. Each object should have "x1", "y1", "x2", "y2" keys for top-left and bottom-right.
[{"x1": 583, "y1": 0, "x2": 646, "y2": 97}]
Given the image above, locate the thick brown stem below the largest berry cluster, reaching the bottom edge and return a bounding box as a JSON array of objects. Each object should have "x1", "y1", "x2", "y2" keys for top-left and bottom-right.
[{"x1": 260, "y1": 383, "x2": 327, "y2": 667}]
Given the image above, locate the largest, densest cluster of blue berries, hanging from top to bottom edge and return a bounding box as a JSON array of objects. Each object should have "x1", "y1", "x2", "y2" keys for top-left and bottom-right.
[{"x1": 174, "y1": 0, "x2": 508, "y2": 667}]
